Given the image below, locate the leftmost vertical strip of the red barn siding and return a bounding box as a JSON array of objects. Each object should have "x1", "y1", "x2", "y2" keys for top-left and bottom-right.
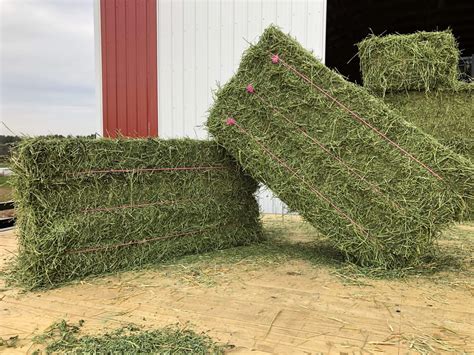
[{"x1": 105, "y1": 0, "x2": 117, "y2": 137}]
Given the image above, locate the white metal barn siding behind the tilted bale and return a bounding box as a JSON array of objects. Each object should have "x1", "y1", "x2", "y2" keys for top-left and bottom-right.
[{"x1": 157, "y1": 0, "x2": 326, "y2": 213}]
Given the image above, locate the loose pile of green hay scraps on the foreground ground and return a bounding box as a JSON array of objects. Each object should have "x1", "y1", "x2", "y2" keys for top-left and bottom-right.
[{"x1": 33, "y1": 320, "x2": 226, "y2": 355}]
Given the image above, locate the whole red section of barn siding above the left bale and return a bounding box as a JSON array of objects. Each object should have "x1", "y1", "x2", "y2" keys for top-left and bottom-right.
[{"x1": 100, "y1": 0, "x2": 158, "y2": 137}]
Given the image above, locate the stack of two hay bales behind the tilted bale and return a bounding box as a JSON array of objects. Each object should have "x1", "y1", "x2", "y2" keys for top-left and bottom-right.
[{"x1": 358, "y1": 30, "x2": 474, "y2": 218}]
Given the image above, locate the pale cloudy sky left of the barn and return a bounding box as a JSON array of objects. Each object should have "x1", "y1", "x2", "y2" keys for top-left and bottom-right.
[{"x1": 0, "y1": 0, "x2": 98, "y2": 136}]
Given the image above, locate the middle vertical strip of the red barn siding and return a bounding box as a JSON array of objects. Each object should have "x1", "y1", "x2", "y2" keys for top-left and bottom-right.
[{"x1": 125, "y1": 1, "x2": 137, "y2": 137}]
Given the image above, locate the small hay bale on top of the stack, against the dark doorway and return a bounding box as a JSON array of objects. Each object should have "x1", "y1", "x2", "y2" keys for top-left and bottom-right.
[{"x1": 357, "y1": 30, "x2": 459, "y2": 94}]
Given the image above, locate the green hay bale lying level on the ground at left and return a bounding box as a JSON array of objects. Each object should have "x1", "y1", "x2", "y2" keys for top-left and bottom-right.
[{"x1": 12, "y1": 138, "x2": 262, "y2": 287}]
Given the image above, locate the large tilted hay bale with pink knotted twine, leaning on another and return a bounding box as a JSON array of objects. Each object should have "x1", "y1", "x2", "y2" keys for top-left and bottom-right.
[{"x1": 207, "y1": 27, "x2": 474, "y2": 268}]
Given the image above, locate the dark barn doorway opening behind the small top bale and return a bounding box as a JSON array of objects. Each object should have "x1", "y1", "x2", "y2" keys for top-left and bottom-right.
[{"x1": 326, "y1": 0, "x2": 474, "y2": 84}]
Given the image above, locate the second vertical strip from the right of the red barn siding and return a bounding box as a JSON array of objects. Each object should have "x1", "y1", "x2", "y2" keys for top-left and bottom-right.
[{"x1": 136, "y1": 0, "x2": 148, "y2": 137}]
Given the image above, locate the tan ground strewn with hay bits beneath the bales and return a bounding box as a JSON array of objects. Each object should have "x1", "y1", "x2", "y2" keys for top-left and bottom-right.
[{"x1": 0, "y1": 217, "x2": 474, "y2": 354}]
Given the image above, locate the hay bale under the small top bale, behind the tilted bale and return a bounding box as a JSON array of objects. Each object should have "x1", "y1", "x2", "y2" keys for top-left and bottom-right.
[{"x1": 384, "y1": 82, "x2": 474, "y2": 220}]
